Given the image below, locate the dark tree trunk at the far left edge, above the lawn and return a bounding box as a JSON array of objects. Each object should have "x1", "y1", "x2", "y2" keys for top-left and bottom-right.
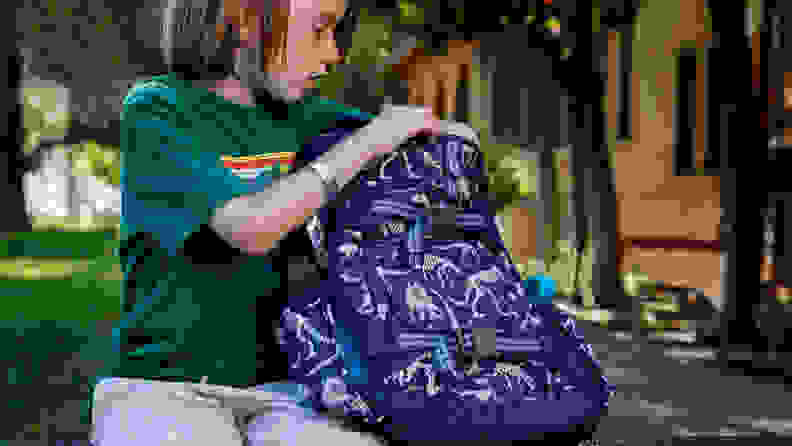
[{"x1": 0, "y1": 41, "x2": 32, "y2": 233}]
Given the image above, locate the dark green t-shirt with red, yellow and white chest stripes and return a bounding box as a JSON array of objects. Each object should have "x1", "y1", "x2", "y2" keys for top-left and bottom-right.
[{"x1": 107, "y1": 75, "x2": 371, "y2": 386}]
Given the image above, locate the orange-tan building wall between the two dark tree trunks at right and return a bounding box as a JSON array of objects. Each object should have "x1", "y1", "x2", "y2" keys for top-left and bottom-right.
[{"x1": 607, "y1": 0, "x2": 721, "y2": 297}]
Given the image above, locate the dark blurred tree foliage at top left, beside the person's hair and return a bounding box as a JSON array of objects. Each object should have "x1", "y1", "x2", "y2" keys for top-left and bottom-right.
[{"x1": 14, "y1": 0, "x2": 165, "y2": 128}]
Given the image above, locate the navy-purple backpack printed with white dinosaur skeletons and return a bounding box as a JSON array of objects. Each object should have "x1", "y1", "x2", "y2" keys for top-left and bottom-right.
[{"x1": 279, "y1": 118, "x2": 613, "y2": 441}]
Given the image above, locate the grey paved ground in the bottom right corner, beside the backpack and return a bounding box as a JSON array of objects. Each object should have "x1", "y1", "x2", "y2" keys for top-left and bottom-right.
[{"x1": 578, "y1": 320, "x2": 792, "y2": 446}]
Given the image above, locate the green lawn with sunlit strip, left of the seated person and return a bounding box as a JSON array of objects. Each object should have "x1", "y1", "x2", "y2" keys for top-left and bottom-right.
[{"x1": 0, "y1": 215, "x2": 122, "y2": 444}]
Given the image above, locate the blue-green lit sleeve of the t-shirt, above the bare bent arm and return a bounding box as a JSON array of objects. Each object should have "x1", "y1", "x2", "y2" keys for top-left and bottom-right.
[{"x1": 121, "y1": 89, "x2": 262, "y2": 254}]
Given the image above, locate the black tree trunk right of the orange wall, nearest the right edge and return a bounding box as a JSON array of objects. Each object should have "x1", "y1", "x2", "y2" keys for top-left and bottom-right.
[{"x1": 711, "y1": 3, "x2": 768, "y2": 365}]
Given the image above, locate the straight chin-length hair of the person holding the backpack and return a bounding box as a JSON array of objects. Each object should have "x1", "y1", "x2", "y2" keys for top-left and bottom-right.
[{"x1": 161, "y1": 0, "x2": 289, "y2": 79}]
